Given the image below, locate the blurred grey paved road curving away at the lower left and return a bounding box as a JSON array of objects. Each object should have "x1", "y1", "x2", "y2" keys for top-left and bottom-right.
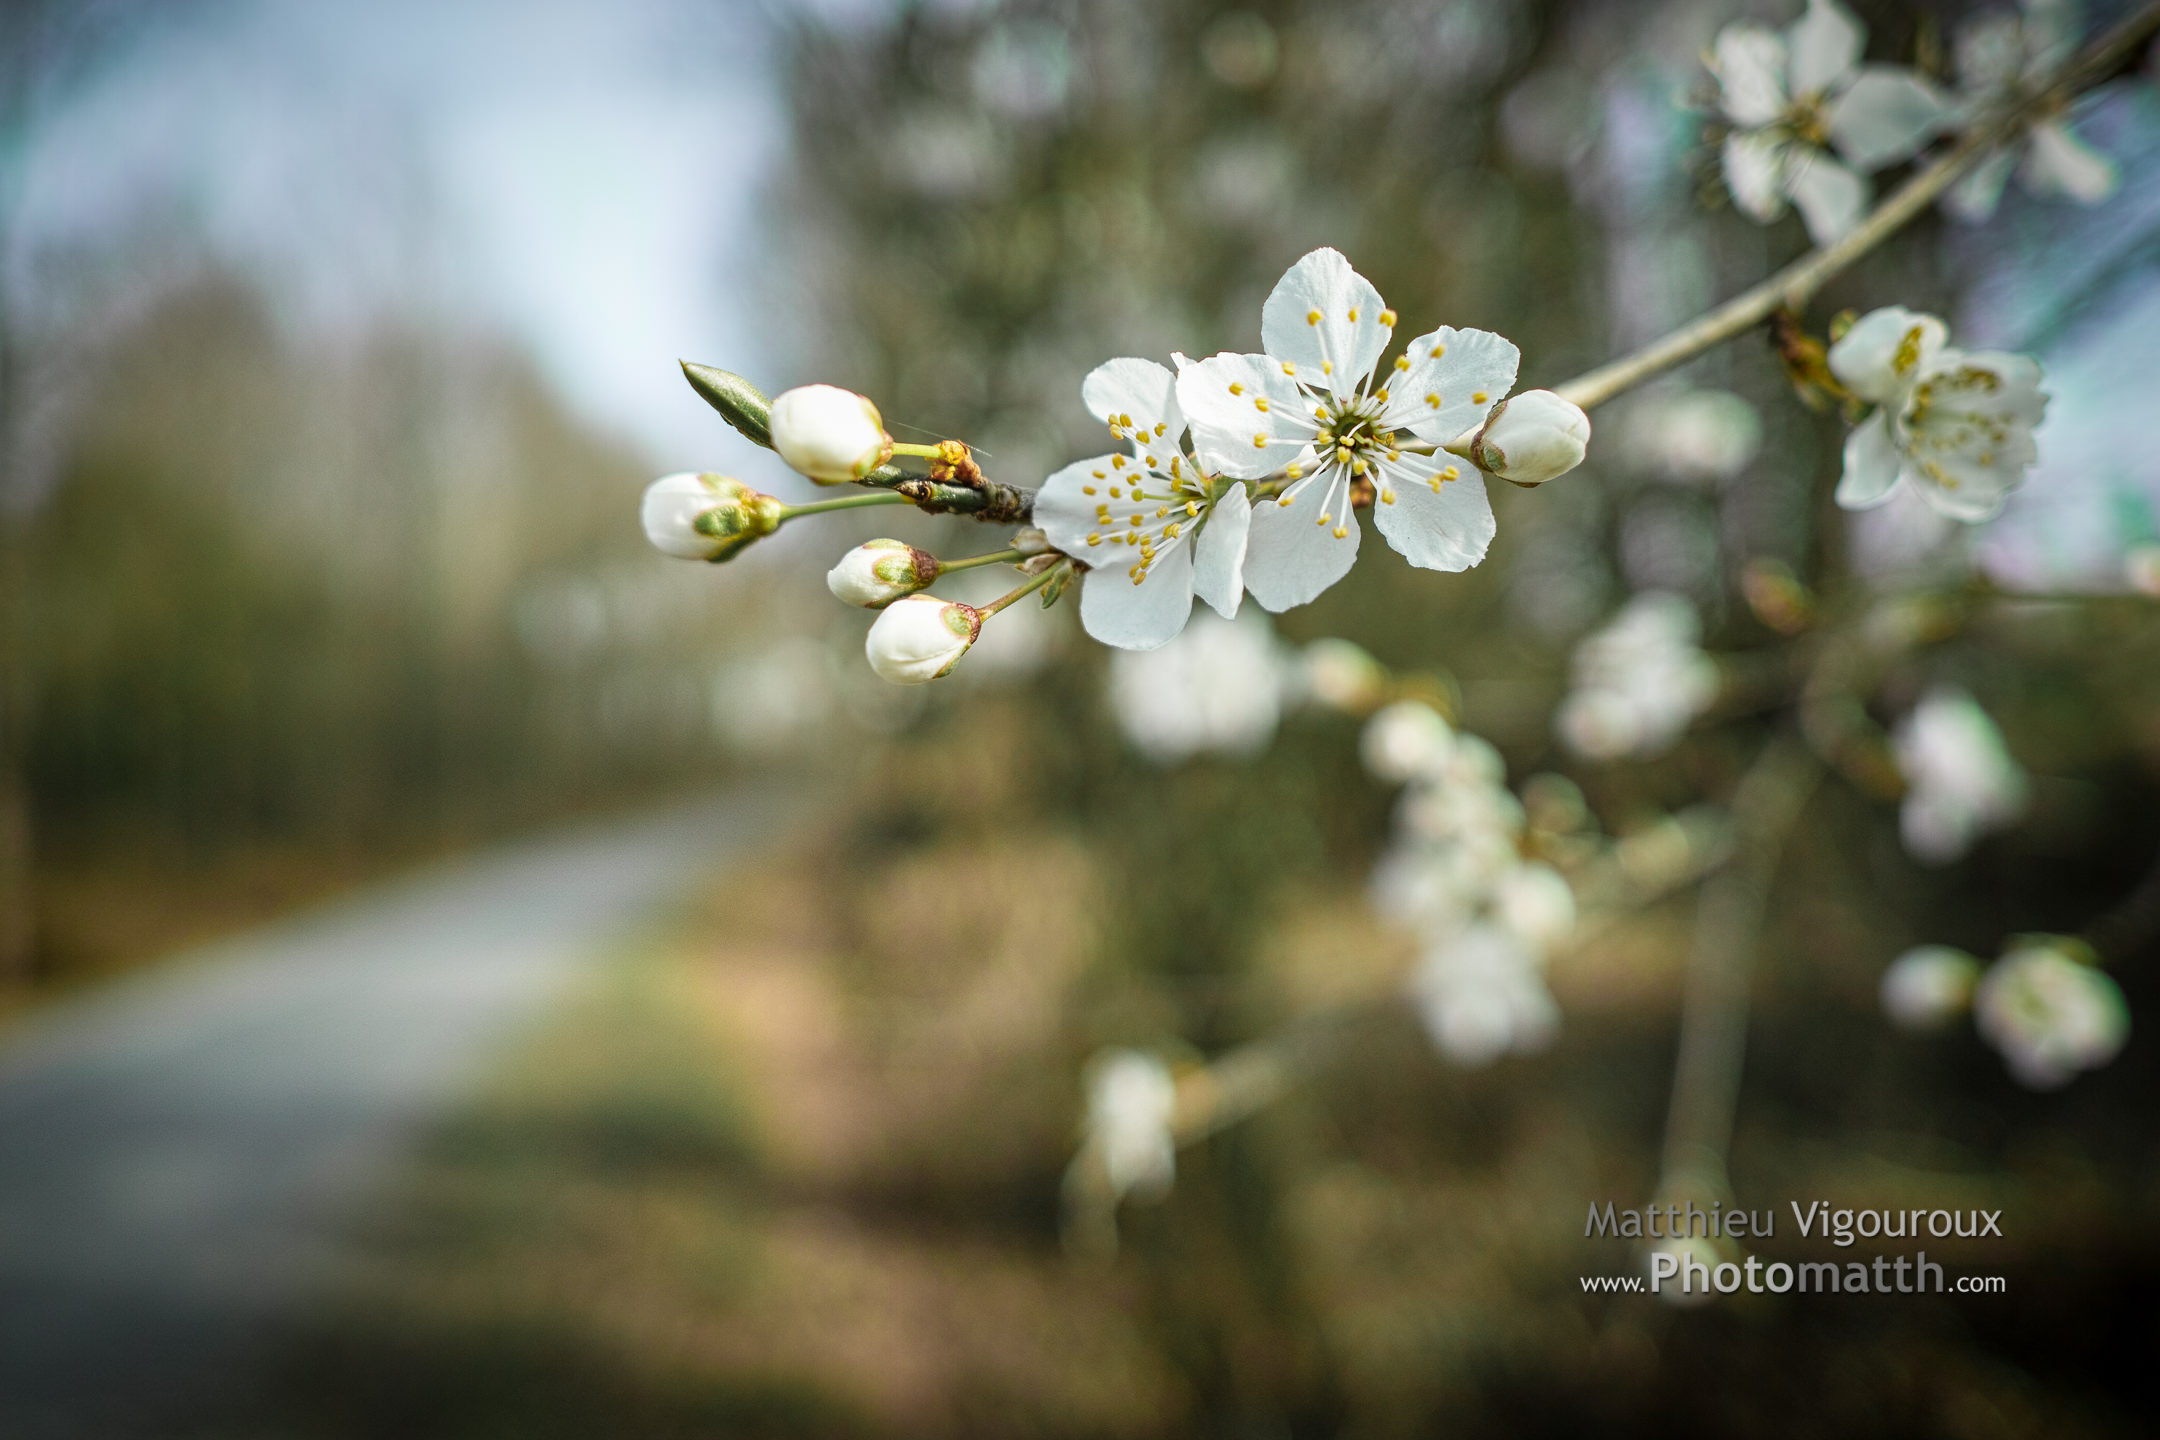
[{"x1": 0, "y1": 797, "x2": 780, "y2": 1440}]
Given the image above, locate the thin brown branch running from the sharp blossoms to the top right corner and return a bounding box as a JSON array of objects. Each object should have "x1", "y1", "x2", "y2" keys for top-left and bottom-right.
[{"x1": 1553, "y1": 0, "x2": 2160, "y2": 410}]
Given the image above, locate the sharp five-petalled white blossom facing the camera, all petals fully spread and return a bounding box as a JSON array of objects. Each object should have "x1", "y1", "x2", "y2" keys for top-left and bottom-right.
[{"x1": 1177, "y1": 250, "x2": 1521, "y2": 611}]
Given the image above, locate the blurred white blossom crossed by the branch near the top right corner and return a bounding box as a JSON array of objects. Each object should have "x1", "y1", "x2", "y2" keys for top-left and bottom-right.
[{"x1": 1942, "y1": 0, "x2": 2121, "y2": 225}]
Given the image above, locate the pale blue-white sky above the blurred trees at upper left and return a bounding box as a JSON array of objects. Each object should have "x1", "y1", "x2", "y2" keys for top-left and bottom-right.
[{"x1": 17, "y1": 0, "x2": 782, "y2": 468}]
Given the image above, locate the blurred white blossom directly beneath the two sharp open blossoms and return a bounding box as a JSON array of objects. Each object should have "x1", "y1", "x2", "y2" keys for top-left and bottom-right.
[{"x1": 1110, "y1": 613, "x2": 1287, "y2": 764}]
